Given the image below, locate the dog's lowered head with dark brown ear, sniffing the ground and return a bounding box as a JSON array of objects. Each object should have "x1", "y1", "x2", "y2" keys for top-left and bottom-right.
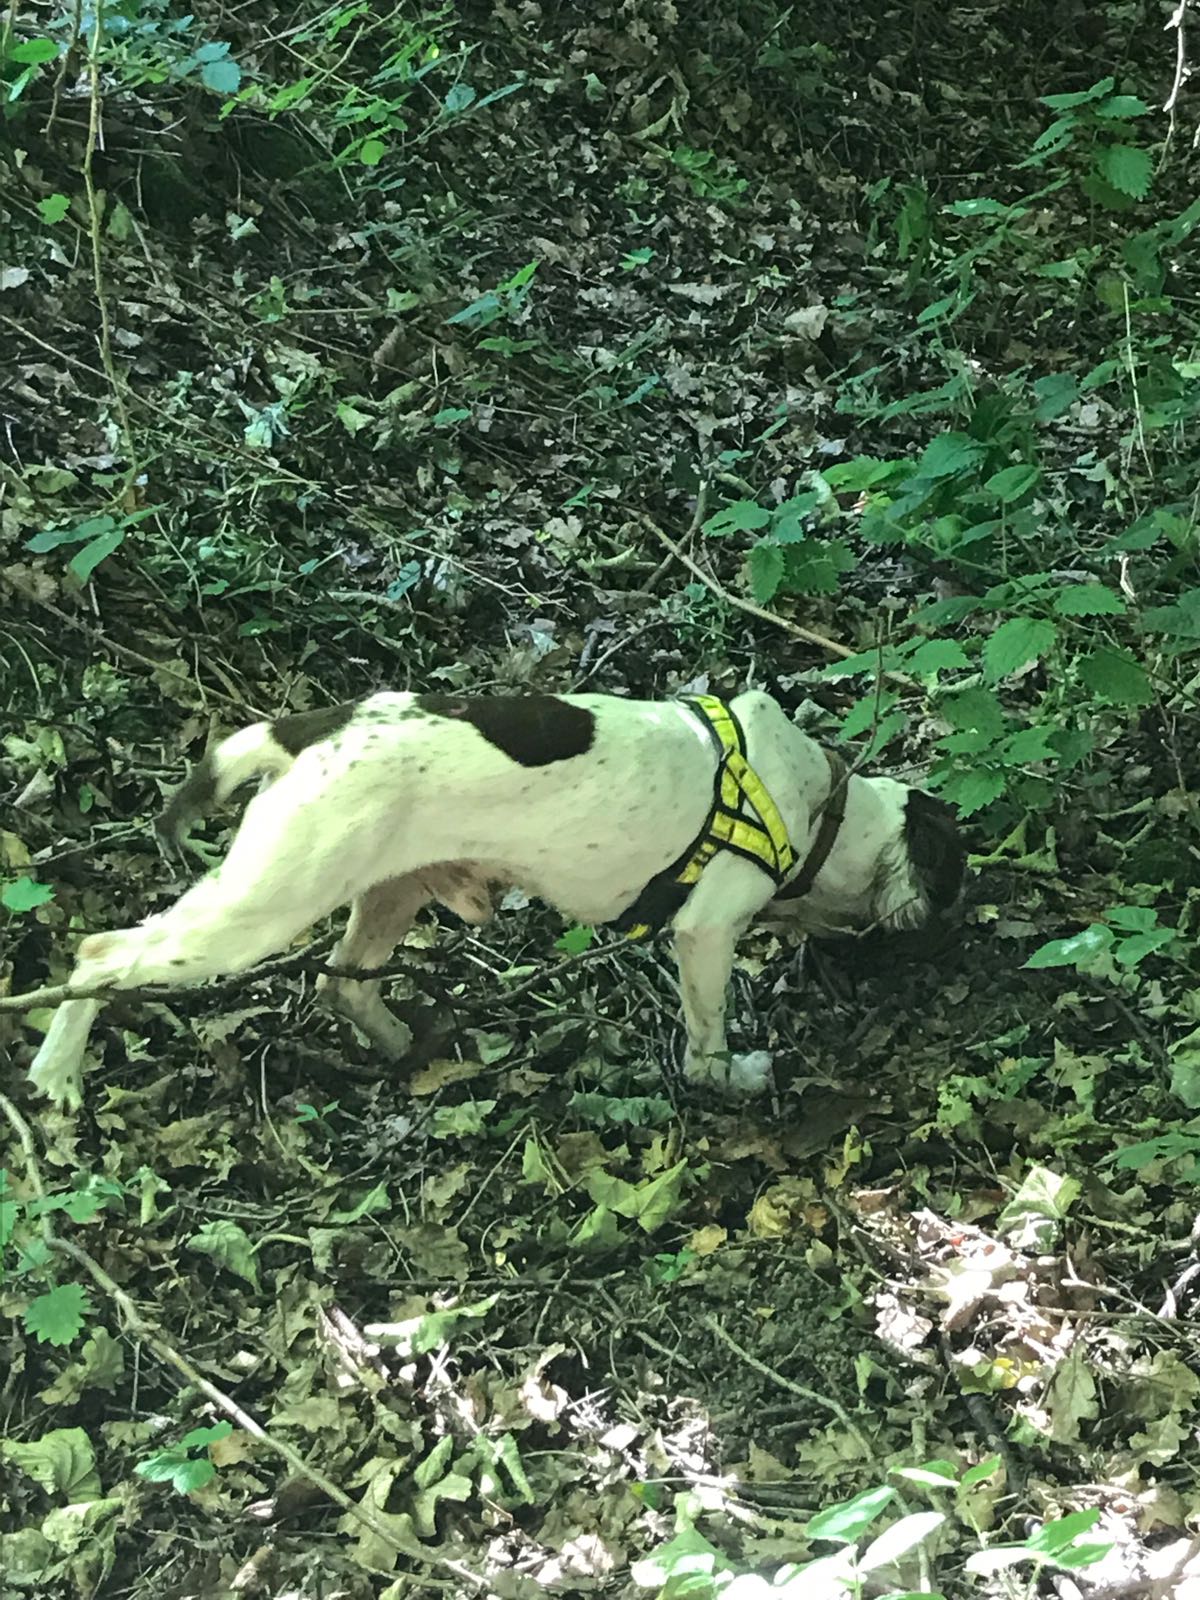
[{"x1": 872, "y1": 779, "x2": 966, "y2": 931}]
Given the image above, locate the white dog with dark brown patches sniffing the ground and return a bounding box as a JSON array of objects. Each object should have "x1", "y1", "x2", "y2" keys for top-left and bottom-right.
[{"x1": 32, "y1": 691, "x2": 963, "y2": 1106}]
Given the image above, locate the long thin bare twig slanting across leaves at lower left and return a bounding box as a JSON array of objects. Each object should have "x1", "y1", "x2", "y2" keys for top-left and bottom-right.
[{"x1": 0, "y1": 1094, "x2": 486, "y2": 1592}]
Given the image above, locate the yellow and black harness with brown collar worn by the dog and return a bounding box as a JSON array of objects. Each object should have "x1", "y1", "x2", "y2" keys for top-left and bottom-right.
[{"x1": 614, "y1": 694, "x2": 848, "y2": 939}]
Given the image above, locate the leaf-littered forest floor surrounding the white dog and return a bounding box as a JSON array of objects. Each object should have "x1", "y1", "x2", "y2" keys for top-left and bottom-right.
[{"x1": 0, "y1": 0, "x2": 1200, "y2": 1600}]
